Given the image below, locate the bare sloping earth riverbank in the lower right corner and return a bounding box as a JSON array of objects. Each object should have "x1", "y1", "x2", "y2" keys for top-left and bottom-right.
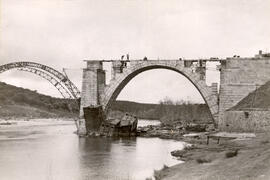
[{"x1": 155, "y1": 133, "x2": 270, "y2": 180}]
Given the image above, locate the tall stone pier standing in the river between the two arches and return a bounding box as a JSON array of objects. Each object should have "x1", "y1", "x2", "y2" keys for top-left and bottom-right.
[{"x1": 79, "y1": 61, "x2": 105, "y2": 135}]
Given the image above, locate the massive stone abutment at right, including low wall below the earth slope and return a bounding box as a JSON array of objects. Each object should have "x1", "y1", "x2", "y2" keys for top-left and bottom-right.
[{"x1": 218, "y1": 57, "x2": 270, "y2": 131}]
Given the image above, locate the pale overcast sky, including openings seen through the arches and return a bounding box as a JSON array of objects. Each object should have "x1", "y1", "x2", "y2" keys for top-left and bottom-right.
[{"x1": 0, "y1": 0, "x2": 270, "y2": 102}]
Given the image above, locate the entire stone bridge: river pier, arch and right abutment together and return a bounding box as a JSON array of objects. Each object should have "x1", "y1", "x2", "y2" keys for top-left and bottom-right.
[{"x1": 79, "y1": 51, "x2": 270, "y2": 133}]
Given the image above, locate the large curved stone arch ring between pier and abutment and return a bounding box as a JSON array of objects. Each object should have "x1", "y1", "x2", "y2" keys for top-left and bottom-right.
[{"x1": 101, "y1": 60, "x2": 218, "y2": 123}]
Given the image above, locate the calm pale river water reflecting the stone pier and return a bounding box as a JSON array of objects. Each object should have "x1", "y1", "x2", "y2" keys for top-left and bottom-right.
[{"x1": 0, "y1": 120, "x2": 183, "y2": 180}]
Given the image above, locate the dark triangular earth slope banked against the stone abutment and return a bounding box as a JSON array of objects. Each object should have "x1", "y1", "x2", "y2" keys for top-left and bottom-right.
[{"x1": 230, "y1": 81, "x2": 270, "y2": 110}]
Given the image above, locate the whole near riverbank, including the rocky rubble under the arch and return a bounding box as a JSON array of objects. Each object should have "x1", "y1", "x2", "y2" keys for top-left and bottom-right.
[{"x1": 75, "y1": 119, "x2": 270, "y2": 180}]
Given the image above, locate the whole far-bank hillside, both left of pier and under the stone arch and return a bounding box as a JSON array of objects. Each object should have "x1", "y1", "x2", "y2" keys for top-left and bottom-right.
[{"x1": 0, "y1": 82, "x2": 211, "y2": 122}]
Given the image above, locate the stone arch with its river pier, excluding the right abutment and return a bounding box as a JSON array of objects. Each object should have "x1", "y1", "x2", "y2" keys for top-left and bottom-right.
[{"x1": 80, "y1": 60, "x2": 218, "y2": 134}]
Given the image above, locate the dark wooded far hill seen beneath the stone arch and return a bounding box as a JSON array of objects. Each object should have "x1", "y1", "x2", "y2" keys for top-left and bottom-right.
[{"x1": 111, "y1": 101, "x2": 212, "y2": 122}]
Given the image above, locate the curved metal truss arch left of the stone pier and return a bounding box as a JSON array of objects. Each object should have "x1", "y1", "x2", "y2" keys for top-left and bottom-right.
[{"x1": 0, "y1": 62, "x2": 80, "y2": 99}]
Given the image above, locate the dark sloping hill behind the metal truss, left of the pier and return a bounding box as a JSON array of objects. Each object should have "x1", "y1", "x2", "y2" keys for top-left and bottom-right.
[{"x1": 0, "y1": 82, "x2": 79, "y2": 118}]
